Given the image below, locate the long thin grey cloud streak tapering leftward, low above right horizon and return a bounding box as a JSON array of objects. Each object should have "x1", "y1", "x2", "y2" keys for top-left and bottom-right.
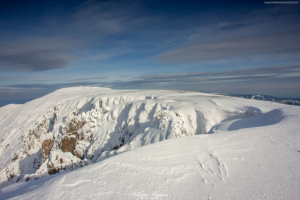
[{"x1": 120, "y1": 66, "x2": 300, "y2": 86}]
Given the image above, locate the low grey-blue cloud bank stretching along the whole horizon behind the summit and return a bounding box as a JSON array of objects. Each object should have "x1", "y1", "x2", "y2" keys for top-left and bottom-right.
[{"x1": 0, "y1": 66, "x2": 300, "y2": 104}]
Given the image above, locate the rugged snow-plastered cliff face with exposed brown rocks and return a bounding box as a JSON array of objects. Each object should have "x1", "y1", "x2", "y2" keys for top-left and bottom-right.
[{"x1": 0, "y1": 89, "x2": 206, "y2": 188}]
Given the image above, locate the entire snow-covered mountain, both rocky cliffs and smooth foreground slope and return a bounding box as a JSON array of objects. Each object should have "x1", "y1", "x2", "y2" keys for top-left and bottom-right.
[{"x1": 0, "y1": 87, "x2": 300, "y2": 199}]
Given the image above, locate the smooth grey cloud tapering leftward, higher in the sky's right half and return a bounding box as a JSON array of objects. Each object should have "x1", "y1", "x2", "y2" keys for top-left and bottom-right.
[{"x1": 157, "y1": 33, "x2": 300, "y2": 63}]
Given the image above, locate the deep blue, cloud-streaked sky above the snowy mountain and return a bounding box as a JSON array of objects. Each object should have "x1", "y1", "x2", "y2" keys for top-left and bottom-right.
[{"x1": 0, "y1": 0, "x2": 300, "y2": 106}]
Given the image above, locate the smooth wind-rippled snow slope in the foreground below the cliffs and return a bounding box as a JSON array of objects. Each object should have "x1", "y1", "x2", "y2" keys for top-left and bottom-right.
[{"x1": 0, "y1": 103, "x2": 300, "y2": 199}]
